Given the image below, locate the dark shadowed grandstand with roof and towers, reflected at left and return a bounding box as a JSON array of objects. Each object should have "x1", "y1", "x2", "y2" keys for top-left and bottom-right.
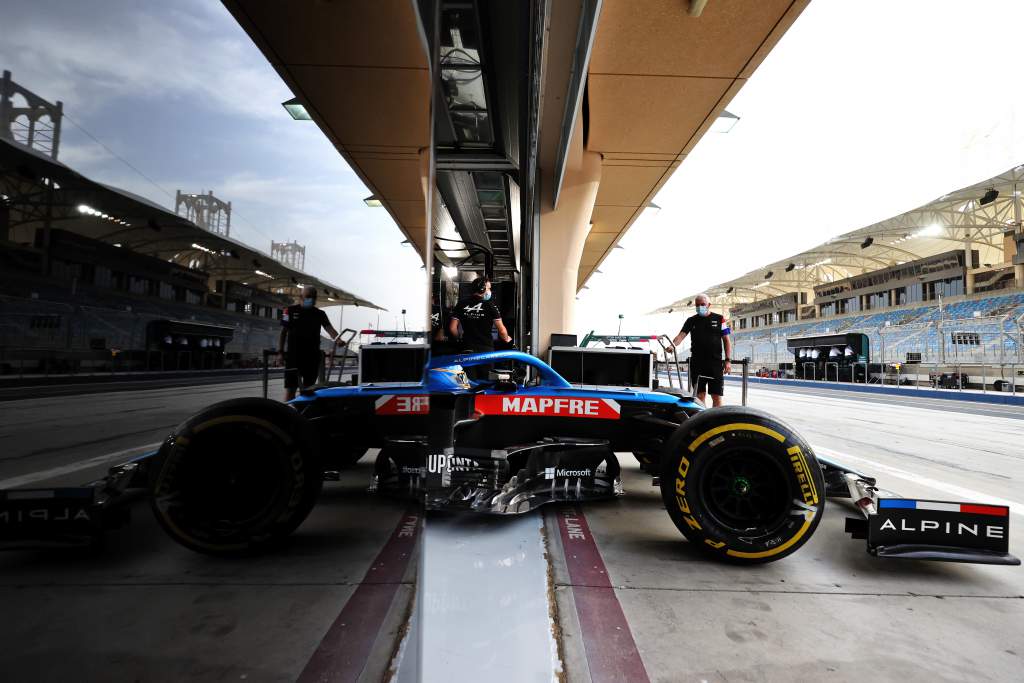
[{"x1": 0, "y1": 74, "x2": 379, "y2": 375}]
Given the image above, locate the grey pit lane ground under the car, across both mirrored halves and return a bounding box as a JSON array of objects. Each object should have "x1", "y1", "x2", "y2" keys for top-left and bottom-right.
[{"x1": 0, "y1": 382, "x2": 1024, "y2": 682}]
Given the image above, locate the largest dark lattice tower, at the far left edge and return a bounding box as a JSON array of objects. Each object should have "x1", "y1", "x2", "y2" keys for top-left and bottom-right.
[{"x1": 0, "y1": 71, "x2": 63, "y2": 159}]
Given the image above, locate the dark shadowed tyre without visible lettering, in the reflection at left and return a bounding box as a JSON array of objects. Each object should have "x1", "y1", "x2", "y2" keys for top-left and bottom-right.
[{"x1": 151, "y1": 398, "x2": 324, "y2": 555}]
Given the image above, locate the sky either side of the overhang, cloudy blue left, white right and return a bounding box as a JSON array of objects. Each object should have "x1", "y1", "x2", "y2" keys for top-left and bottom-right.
[{"x1": 6, "y1": 0, "x2": 1024, "y2": 333}]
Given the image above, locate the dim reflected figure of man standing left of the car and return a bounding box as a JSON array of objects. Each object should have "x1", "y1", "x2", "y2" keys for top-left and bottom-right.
[{"x1": 278, "y1": 287, "x2": 338, "y2": 401}]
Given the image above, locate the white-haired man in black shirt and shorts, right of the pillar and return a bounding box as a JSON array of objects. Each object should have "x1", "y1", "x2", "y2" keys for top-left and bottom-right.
[{"x1": 672, "y1": 294, "x2": 732, "y2": 408}]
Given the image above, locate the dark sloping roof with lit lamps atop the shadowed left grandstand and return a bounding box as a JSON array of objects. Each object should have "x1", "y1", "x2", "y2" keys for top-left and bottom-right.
[{"x1": 0, "y1": 139, "x2": 384, "y2": 310}]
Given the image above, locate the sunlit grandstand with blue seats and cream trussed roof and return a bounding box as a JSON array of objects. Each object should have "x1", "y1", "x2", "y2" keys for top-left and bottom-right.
[{"x1": 654, "y1": 166, "x2": 1024, "y2": 386}]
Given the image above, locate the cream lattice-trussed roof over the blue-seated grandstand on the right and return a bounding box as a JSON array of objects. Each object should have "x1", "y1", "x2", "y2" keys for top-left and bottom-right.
[{"x1": 652, "y1": 165, "x2": 1024, "y2": 313}]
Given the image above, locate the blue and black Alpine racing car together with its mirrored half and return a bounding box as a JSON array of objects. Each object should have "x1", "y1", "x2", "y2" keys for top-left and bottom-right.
[{"x1": 0, "y1": 351, "x2": 1019, "y2": 564}]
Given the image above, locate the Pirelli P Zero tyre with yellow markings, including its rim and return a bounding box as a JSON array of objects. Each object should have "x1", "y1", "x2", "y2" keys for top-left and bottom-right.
[{"x1": 660, "y1": 405, "x2": 825, "y2": 564}]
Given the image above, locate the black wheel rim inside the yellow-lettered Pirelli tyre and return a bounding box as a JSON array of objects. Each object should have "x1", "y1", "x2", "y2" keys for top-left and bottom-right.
[{"x1": 700, "y1": 449, "x2": 792, "y2": 532}]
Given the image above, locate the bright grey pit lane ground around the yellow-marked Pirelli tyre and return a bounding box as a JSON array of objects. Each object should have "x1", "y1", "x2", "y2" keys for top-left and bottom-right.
[{"x1": 554, "y1": 385, "x2": 1024, "y2": 681}]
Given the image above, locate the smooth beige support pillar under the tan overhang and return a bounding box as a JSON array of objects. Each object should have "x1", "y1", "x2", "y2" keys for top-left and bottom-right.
[{"x1": 536, "y1": 152, "x2": 601, "y2": 357}]
